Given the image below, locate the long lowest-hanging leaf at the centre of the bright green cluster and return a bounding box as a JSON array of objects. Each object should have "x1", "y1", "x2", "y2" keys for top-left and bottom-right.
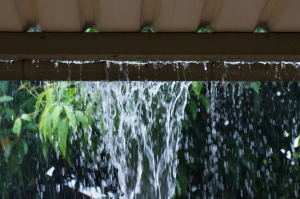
[{"x1": 58, "y1": 119, "x2": 69, "y2": 157}]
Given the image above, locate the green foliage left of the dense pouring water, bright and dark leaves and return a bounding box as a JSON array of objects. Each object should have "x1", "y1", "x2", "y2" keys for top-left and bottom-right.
[{"x1": 0, "y1": 81, "x2": 118, "y2": 198}]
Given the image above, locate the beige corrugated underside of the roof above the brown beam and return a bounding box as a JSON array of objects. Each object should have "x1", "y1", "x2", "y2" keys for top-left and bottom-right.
[{"x1": 0, "y1": 0, "x2": 300, "y2": 32}]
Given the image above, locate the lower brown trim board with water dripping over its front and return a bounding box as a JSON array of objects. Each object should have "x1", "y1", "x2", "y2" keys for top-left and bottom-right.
[{"x1": 0, "y1": 60, "x2": 300, "y2": 81}]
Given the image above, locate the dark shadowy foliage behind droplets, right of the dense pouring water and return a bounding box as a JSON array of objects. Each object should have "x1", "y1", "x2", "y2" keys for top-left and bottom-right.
[{"x1": 176, "y1": 82, "x2": 300, "y2": 199}]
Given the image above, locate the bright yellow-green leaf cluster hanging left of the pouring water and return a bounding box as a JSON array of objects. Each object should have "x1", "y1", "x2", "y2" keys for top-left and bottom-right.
[{"x1": 20, "y1": 82, "x2": 93, "y2": 157}]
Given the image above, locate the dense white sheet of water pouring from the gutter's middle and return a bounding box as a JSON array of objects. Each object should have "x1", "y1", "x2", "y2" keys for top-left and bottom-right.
[{"x1": 80, "y1": 82, "x2": 190, "y2": 198}]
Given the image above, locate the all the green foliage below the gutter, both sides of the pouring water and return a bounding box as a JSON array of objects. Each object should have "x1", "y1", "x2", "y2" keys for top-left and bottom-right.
[{"x1": 0, "y1": 81, "x2": 300, "y2": 199}]
